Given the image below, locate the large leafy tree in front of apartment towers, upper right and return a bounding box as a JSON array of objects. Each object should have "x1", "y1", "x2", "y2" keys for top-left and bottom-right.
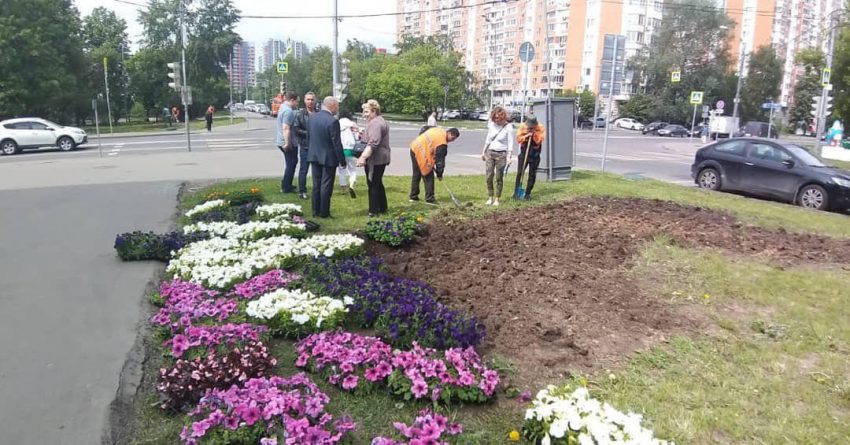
[{"x1": 627, "y1": 0, "x2": 735, "y2": 122}]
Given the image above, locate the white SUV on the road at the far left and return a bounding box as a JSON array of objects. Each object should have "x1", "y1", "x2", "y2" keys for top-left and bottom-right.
[{"x1": 0, "y1": 117, "x2": 88, "y2": 155}]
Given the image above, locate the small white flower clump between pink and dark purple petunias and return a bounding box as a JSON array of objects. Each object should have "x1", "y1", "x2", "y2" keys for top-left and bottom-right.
[{"x1": 245, "y1": 289, "x2": 351, "y2": 338}]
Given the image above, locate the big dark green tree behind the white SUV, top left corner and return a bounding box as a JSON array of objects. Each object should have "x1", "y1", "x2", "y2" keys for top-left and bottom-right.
[{"x1": 0, "y1": 0, "x2": 91, "y2": 123}]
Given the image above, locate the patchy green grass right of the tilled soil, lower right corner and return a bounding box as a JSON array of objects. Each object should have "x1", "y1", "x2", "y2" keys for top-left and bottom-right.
[{"x1": 593, "y1": 242, "x2": 850, "y2": 444}]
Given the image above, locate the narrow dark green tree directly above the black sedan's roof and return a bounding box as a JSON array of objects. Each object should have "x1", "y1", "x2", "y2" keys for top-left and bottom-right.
[{"x1": 741, "y1": 45, "x2": 784, "y2": 120}]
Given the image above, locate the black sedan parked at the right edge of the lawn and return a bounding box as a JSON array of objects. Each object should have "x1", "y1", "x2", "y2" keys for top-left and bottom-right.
[{"x1": 691, "y1": 138, "x2": 850, "y2": 210}]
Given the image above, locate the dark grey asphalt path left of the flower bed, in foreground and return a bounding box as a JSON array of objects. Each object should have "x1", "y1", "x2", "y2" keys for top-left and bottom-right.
[{"x1": 0, "y1": 180, "x2": 178, "y2": 445}]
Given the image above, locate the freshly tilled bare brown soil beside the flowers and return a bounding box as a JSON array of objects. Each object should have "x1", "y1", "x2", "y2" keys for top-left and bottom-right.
[{"x1": 374, "y1": 198, "x2": 850, "y2": 385}]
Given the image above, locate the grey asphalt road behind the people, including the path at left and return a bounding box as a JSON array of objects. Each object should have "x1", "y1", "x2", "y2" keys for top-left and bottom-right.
[{"x1": 0, "y1": 113, "x2": 699, "y2": 444}]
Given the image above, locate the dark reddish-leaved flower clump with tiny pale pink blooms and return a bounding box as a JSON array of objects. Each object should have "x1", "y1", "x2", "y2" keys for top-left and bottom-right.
[{"x1": 156, "y1": 341, "x2": 277, "y2": 409}]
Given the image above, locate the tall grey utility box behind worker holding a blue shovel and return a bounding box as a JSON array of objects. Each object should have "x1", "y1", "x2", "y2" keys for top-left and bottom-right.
[{"x1": 531, "y1": 98, "x2": 576, "y2": 181}]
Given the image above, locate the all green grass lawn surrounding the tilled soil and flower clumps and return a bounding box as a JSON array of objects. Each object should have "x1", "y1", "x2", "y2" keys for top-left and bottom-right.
[{"x1": 132, "y1": 172, "x2": 850, "y2": 444}]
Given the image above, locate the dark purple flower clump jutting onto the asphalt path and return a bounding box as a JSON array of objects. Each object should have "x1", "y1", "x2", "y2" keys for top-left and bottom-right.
[{"x1": 114, "y1": 230, "x2": 207, "y2": 262}]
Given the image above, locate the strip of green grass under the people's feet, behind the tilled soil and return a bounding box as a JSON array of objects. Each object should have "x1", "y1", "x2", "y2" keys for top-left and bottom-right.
[{"x1": 181, "y1": 171, "x2": 850, "y2": 237}]
